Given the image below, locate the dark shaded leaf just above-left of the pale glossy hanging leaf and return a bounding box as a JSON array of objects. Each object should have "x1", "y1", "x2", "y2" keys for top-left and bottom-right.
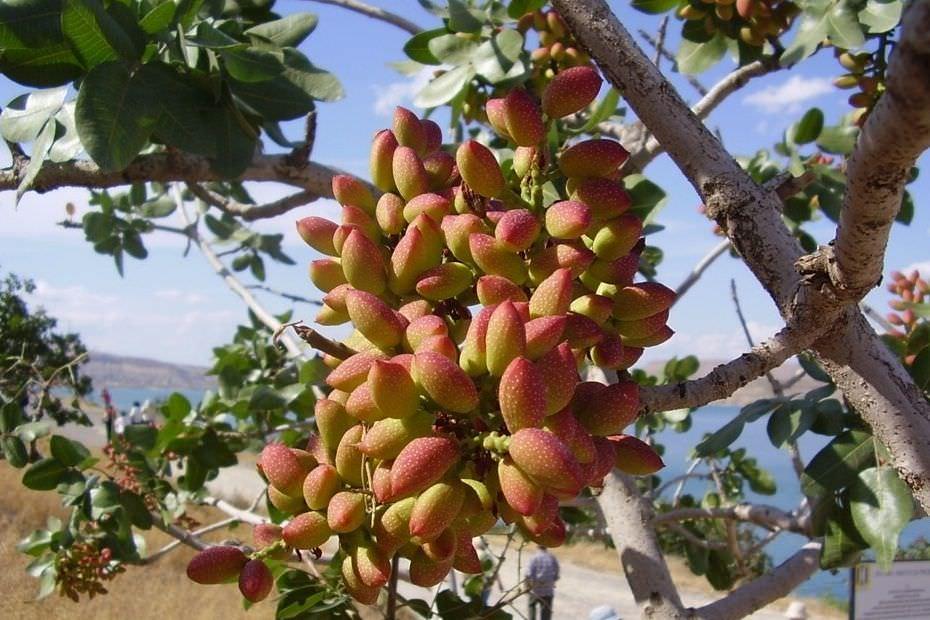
[{"x1": 801, "y1": 430, "x2": 875, "y2": 497}]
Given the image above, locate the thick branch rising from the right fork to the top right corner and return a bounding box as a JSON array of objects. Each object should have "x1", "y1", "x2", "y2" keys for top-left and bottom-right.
[{"x1": 826, "y1": 0, "x2": 930, "y2": 300}]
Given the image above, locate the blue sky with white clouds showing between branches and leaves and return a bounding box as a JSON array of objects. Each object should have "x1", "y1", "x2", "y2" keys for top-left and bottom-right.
[{"x1": 0, "y1": 0, "x2": 930, "y2": 364}]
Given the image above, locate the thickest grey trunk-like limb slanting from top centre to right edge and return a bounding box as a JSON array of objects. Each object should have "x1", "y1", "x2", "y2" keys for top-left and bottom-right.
[{"x1": 553, "y1": 0, "x2": 930, "y2": 510}]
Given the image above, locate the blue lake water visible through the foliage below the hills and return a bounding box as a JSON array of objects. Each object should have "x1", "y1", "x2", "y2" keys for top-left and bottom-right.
[{"x1": 94, "y1": 388, "x2": 930, "y2": 599}]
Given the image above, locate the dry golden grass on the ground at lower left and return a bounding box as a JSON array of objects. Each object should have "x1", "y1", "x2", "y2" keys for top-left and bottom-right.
[{"x1": 0, "y1": 461, "x2": 274, "y2": 620}]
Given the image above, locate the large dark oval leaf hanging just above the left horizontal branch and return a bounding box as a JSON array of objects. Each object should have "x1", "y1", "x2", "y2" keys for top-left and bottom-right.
[{"x1": 74, "y1": 62, "x2": 163, "y2": 170}]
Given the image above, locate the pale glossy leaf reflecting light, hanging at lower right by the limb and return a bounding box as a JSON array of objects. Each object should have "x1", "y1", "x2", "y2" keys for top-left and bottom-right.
[{"x1": 849, "y1": 467, "x2": 914, "y2": 570}]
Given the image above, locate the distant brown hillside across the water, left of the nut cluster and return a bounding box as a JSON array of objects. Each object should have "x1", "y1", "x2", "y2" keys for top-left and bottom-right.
[{"x1": 82, "y1": 351, "x2": 216, "y2": 390}]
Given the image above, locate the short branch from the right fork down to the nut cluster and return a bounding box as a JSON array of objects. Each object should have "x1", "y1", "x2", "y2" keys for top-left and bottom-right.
[{"x1": 640, "y1": 326, "x2": 828, "y2": 413}]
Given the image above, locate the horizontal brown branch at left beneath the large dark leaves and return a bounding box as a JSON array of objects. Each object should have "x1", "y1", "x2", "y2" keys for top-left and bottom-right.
[{"x1": 0, "y1": 152, "x2": 342, "y2": 198}]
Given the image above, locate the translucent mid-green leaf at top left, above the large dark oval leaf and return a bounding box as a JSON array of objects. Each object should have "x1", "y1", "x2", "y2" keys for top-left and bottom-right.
[{"x1": 61, "y1": 0, "x2": 138, "y2": 69}]
